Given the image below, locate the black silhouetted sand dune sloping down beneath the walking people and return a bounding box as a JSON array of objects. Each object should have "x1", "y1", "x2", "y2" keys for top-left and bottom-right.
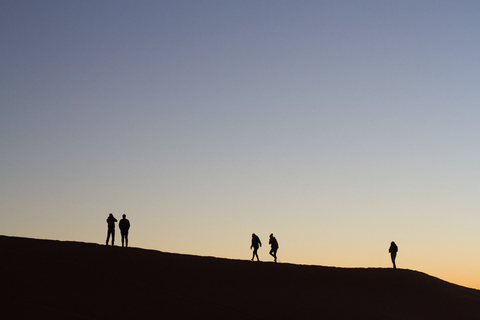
[{"x1": 0, "y1": 236, "x2": 480, "y2": 320}]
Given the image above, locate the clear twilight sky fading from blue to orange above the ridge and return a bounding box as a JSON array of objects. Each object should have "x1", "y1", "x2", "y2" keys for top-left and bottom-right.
[{"x1": 0, "y1": 0, "x2": 480, "y2": 289}]
